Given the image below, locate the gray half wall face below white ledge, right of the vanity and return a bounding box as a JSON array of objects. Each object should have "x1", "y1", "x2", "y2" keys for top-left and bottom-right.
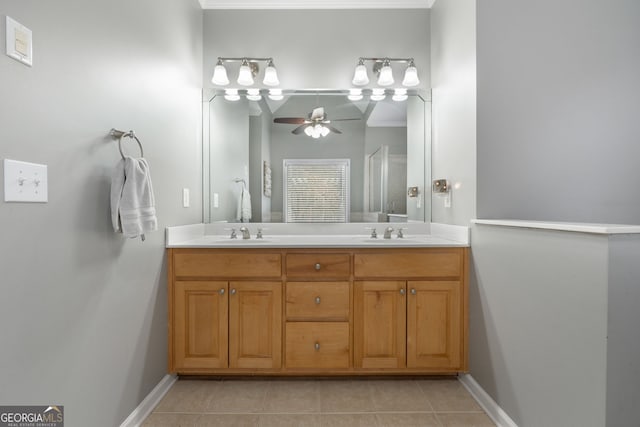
[{"x1": 469, "y1": 225, "x2": 608, "y2": 427}]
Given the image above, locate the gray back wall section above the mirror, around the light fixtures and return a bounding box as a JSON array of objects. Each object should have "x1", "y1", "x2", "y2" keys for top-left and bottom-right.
[{"x1": 203, "y1": 9, "x2": 430, "y2": 89}]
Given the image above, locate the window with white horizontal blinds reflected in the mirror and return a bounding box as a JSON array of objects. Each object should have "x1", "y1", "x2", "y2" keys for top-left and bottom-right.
[{"x1": 283, "y1": 159, "x2": 350, "y2": 222}]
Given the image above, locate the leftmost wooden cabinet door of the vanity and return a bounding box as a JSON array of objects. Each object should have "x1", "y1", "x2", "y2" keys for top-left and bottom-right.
[{"x1": 173, "y1": 281, "x2": 228, "y2": 371}]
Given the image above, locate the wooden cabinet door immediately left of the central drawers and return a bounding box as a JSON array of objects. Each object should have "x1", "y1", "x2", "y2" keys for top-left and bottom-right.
[{"x1": 229, "y1": 281, "x2": 282, "y2": 369}]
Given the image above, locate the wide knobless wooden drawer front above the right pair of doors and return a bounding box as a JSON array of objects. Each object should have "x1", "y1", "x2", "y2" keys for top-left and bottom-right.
[{"x1": 353, "y1": 249, "x2": 463, "y2": 278}]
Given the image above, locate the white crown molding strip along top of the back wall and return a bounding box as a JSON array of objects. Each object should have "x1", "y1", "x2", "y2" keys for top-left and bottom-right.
[{"x1": 199, "y1": 0, "x2": 435, "y2": 9}]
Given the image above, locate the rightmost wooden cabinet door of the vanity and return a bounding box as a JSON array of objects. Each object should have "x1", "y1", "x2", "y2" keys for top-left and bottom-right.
[{"x1": 407, "y1": 281, "x2": 462, "y2": 369}]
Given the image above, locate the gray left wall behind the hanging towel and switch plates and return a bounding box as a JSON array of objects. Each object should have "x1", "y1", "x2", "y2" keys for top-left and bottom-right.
[{"x1": 0, "y1": 0, "x2": 202, "y2": 427}]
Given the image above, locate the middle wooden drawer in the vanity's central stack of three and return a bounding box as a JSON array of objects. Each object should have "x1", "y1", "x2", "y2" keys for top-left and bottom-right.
[{"x1": 286, "y1": 282, "x2": 349, "y2": 321}]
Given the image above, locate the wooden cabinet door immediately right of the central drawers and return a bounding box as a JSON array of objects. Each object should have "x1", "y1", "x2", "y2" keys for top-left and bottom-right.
[{"x1": 353, "y1": 281, "x2": 407, "y2": 368}]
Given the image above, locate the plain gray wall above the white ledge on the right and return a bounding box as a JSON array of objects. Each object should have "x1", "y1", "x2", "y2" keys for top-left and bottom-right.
[{"x1": 476, "y1": 0, "x2": 640, "y2": 224}]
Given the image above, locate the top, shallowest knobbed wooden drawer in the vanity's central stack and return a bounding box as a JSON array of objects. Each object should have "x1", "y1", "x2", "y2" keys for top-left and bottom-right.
[{"x1": 286, "y1": 254, "x2": 351, "y2": 278}]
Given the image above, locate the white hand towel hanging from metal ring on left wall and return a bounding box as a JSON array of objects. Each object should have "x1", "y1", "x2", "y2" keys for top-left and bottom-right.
[{"x1": 111, "y1": 157, "x2": 158, "y2": 240}]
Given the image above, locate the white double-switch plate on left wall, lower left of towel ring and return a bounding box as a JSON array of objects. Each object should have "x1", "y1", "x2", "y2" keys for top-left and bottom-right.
[{"x1": 4, "y1": 159, "x2": 49, "y2": 203}]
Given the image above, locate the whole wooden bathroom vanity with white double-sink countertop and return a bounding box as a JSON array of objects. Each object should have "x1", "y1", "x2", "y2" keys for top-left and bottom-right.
[{"x1": 167, "y1": 226, "x2": 468, "y2": 375}]
